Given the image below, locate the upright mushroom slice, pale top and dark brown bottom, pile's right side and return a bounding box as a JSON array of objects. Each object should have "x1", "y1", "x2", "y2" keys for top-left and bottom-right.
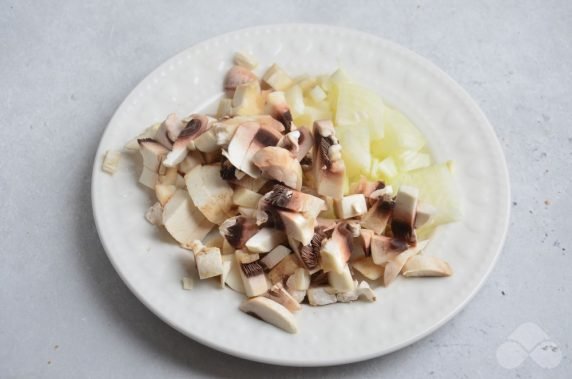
[{"x1": 391, "y1": 185, "x2": 419, "y2": 244}]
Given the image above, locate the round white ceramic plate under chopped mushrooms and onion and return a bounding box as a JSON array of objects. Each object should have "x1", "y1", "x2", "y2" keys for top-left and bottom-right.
[{"x1": 92, "y1": 25, "x2": 510, "y2": 366}]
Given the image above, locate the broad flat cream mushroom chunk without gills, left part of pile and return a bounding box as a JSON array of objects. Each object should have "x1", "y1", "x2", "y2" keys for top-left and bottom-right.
[{"x1": 185, "y1": 164, "x2": 234, "y2": 224}]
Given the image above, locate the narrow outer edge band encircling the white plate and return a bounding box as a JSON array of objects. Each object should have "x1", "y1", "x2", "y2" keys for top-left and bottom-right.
[{"x1": 90, "y1": 23, "x2": 511, "y2": 367}]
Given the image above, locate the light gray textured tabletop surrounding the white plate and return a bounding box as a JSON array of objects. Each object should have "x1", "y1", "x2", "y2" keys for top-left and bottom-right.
[{"x1": 0, "y1": 0, "x2": 572, "y2": 378}]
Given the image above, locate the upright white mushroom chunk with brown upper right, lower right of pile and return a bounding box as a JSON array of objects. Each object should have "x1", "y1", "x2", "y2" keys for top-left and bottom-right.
[{"x1": 320, "y1": 222, "x2": 353, "y2": 273}]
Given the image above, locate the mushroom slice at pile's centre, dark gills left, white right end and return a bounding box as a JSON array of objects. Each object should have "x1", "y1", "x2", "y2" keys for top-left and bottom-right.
[{"x1": 267, "y1": 184, "x2": 326, "y2": 218}]
